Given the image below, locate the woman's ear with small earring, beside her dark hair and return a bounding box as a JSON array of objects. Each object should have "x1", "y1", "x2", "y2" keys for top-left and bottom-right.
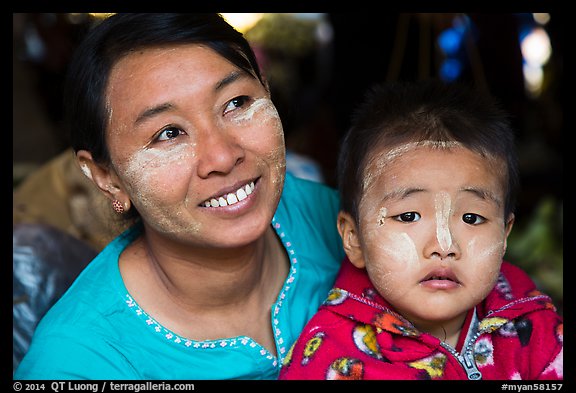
[{"x1": 76, "y1": 150, "x2": 130, "y2": 211}]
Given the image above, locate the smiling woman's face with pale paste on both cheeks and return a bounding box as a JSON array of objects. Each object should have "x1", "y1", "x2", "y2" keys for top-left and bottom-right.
[{"x1": 106, "y1": 45, "x2": 285, "y2": 248}]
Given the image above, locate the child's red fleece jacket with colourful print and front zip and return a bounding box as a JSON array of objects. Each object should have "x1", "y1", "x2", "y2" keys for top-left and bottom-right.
[{"x1": 280, "y1": 260, "x2": 563, "y2": 380}]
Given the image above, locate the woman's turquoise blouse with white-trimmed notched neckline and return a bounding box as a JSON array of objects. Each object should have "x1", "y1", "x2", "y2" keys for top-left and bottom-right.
[{"x1": 14, "y1": 174, "x2": 344, "y2": 380}]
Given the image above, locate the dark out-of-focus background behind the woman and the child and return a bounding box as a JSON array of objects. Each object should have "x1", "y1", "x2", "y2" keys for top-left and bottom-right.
[{"x1": 12, "y1": 13, "x2": 564, "y2": 313}]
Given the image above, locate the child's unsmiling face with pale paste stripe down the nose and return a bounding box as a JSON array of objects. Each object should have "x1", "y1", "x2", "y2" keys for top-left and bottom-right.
[{"x1": 340, "y1": 145, "x2": 513, "y2": 326}]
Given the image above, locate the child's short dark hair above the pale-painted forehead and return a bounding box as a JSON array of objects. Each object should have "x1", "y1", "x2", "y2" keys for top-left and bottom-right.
[{"x1": 338, "y1": 80, "x2": 519, "y2": 221}]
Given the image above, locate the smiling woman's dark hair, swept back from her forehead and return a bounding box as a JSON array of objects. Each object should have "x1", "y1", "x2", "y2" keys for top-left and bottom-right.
[{"x1": 64, "y1": 13, "x2": 266, "y2": 163}]
